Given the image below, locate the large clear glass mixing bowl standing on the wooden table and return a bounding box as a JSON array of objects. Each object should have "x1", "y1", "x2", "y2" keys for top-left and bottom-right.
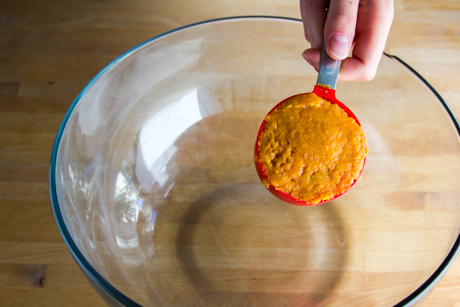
[{"x1": 50, "y1": 17, "x2": 460, "y2": 307}]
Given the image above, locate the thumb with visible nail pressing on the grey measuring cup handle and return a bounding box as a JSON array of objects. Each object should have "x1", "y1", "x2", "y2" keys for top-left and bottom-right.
[{"x1": 324, "y1": 0, "x2": 359, "y2": 60}]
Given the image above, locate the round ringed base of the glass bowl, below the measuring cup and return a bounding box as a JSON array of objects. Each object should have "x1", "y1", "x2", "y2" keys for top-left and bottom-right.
[{"x1": 171, "y1": 184, "x2": 347, "y2": 306}]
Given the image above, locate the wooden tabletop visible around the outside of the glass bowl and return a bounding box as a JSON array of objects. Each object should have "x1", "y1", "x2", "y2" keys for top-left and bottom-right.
[{"x1": 0, "y1": 0, "x2": 460, "y2": 307}]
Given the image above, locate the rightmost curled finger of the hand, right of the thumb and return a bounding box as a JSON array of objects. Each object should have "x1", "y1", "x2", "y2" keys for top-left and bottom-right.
[{"x1": 339, "y1": 0, "x2": 394, "y2": 81}]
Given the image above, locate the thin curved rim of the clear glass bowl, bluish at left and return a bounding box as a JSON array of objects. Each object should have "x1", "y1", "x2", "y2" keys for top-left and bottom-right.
[{"x1": 49, "y1": 15, "x2": 460, "y2": 307}]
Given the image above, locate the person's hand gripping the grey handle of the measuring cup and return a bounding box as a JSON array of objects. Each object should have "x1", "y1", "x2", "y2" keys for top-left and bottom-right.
[{"x1": 300, "y1": 0, "x2": 394, "y2": 81}]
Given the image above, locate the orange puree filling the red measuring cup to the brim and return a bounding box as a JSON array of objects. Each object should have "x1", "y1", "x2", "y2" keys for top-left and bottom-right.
[{"x1": 256, "y1": 93, "x2": 368, "y2": 204}]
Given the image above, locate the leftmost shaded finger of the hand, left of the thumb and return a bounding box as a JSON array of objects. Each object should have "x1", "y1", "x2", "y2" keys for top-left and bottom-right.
[{"x1": 300, "y1": 0, "x2": 329, "y2": 48}]
